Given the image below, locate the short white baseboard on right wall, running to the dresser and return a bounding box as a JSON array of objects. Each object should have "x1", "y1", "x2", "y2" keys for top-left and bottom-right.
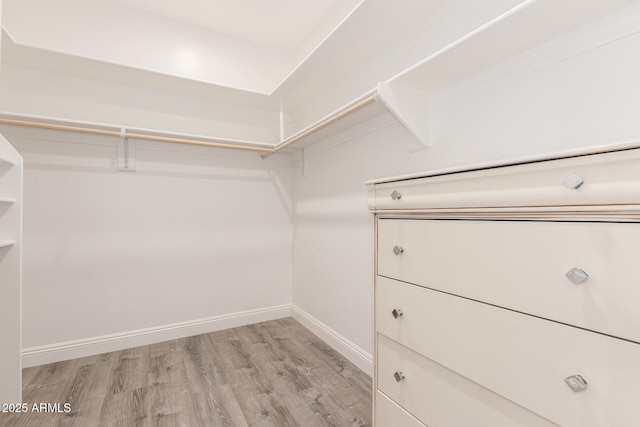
[{"x1": 291, "y1": 305, "x2": 373, "y2": 376}]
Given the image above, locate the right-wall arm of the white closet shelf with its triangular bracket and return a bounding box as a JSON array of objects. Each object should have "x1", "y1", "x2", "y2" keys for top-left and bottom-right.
[{"x1": 290, "y1": 0, "x2": 635, "y2": 157}]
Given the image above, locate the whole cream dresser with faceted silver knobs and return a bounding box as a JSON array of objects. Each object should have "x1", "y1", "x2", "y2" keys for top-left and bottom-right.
[{"x1": 367, "y1": 144, "x2": 640, "y2": 427}]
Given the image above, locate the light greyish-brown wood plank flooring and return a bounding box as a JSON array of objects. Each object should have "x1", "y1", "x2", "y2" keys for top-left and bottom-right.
[{"x1": 0, "y1": 318, "x2": 371, "y2": 427}]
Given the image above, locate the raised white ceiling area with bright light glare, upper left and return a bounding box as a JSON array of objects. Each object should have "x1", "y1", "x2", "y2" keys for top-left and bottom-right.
[{"x1": 2, "y1": 0, "x2": 363, "y2": 95}]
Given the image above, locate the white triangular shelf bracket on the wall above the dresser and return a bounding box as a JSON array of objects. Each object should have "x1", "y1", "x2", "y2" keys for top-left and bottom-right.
[{"x1": 375, "y1": 82, "x2": 431, "y2": 152}]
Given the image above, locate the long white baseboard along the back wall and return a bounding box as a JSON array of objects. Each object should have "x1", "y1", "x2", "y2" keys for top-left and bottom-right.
[{"x1": 22, "y1": 304, "x2": 291, "y2": 368}]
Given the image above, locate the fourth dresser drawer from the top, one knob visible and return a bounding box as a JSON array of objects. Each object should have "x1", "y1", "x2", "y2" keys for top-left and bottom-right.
[{"x1": 377, "y1": 335, "x2": 555, "y2": 427}]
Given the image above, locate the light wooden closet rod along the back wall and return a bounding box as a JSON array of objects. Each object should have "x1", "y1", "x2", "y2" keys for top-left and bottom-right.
[{"x1": 0, "y1": 118, "x2": 273, "y2": 153}]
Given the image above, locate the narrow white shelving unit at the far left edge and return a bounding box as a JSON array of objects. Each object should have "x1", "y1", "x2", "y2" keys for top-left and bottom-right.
[{"x1": 0, "y1": 135, "x2": 23, "y2": 403}]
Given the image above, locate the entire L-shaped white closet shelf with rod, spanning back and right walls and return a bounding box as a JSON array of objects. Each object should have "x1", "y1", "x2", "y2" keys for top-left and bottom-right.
[{"x1": 0, "y1": 0, "x2": 637, "y2": 158}]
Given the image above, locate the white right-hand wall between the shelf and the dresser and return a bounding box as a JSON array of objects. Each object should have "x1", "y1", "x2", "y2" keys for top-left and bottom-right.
[{"x1": 293, "y1": 8, "x2": 640, "y2": 374}]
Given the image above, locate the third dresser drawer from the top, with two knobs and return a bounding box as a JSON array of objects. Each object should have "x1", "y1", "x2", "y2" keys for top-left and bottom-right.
[{"x1": 376, "y1": 277, "x2": 640, "y2": 427}]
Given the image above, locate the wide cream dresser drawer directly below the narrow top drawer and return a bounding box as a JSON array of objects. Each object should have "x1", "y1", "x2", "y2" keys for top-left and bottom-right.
[{"x1": 378, "y1": 219, "x2": 640, "y2": 342}]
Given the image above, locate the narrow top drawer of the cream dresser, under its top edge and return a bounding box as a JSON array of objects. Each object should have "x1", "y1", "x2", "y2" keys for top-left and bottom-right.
[{"x1": 370, "y1": 149, "x2": 640, "y2": 211}]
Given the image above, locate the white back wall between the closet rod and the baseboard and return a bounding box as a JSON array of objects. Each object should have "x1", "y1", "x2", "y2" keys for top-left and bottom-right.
[{"x1": 2, "y1": 127, "x2": 292, "y2": 361}]
